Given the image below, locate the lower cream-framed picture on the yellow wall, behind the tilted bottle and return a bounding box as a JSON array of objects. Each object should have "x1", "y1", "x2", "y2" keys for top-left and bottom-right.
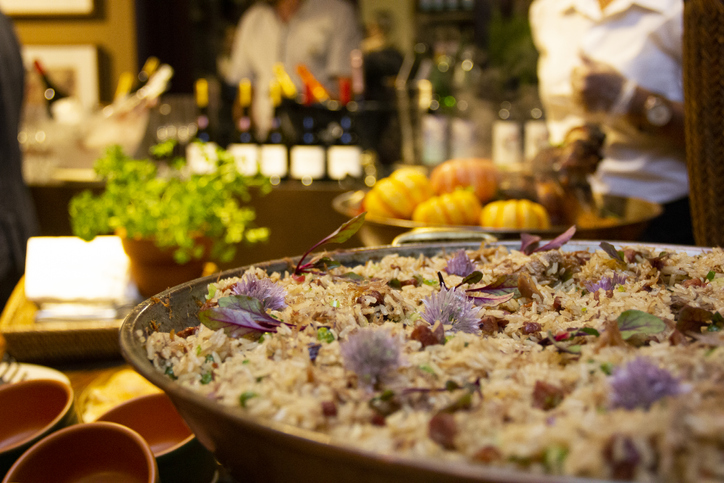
[{"x1": 22, "y1": 44, "x2": 99, "y2": 110}]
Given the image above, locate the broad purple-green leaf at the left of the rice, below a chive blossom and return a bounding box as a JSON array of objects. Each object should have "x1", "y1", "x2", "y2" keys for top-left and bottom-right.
[{"x1": 199, "y1": 295, "x2": 288, "y2": 337}]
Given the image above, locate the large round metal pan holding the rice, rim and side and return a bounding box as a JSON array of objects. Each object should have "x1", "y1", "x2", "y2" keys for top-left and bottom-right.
[{"x1": 120, "y1": 241, "x2": 703, "y2": 483}]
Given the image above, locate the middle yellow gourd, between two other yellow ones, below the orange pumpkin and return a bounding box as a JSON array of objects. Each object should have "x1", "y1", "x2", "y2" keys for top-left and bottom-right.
[{"x1": 412, "y1": 189, "x2": 482, "y2": 225}]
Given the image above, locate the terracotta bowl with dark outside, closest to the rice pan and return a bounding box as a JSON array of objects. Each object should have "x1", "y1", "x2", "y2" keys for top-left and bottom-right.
[{"x1": 97, "y1": 393, "x2": 218, "y2": 483}]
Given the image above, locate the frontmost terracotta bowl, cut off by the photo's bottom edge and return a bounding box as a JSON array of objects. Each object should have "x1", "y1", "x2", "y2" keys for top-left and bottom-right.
[{"x1": 3, "y1": 422, "x2": 160, "y2": 483}]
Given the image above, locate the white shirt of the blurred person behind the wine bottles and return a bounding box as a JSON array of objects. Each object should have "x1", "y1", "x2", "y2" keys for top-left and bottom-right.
[{"x1": 226, "y1": 0, "x2": 362, "y2": 138}]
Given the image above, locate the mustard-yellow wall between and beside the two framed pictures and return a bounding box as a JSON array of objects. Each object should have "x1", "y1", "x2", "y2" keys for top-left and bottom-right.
[{"x1": 13, "y1": 0, "x2": 138, "y2": 103}]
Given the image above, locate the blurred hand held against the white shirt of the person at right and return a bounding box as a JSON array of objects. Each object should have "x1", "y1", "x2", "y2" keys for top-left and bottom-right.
[{"x1": 571, "y1": 55, "x2": 628, "y2": 114}]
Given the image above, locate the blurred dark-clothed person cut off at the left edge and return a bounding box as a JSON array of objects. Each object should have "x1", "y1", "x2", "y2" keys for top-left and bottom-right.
[{"x1": 0, "y1": 12, "x2": 38, "y2": 310}]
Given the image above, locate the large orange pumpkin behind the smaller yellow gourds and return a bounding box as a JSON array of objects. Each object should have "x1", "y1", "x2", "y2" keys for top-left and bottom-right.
[{"x1": 430, "y1": 158, "x2": 498, "y2": 203}]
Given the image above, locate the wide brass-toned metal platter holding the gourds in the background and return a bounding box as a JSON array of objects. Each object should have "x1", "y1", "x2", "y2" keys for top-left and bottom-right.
[{"x1": 332, "y1": 190, "x2": 662, "y2": 247}]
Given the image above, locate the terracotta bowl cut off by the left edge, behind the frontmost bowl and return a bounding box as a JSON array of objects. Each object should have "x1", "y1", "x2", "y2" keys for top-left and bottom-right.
[{"x1": 0, "y1": 379, "x2": 78, "y2": 474}]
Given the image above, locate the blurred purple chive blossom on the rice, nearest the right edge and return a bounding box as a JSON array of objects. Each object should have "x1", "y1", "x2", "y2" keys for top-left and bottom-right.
[{"x1": 610, "y1": 357, "x2": 690, "y2": 410}]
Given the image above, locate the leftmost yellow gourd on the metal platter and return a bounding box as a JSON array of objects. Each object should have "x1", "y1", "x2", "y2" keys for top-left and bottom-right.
[{"x1": 364, "y1": 168, "x2": 435, "y2": 220}]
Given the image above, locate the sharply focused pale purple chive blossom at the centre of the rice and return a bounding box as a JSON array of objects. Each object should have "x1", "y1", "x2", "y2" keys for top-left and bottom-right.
[{"x1": 421, "y1": 288, "x2": 480, "y2": 334}]
